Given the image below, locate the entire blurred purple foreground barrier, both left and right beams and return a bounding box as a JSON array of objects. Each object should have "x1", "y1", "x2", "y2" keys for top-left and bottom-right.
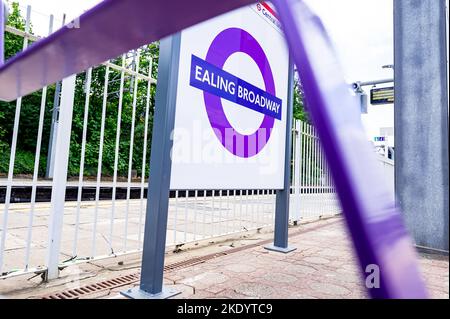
[{"x1": 0, "y1": 0, "x2": 427, "y2": 298}]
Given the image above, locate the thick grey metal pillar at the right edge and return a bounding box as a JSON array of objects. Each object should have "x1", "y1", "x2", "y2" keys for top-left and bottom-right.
[{"x1": 394, "y1": 0, "x2": 449, "y2": 253}]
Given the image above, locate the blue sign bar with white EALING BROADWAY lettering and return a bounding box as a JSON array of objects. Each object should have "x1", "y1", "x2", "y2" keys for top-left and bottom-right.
[{"x1": 190, "y1": 55, "x2": 283, "y2": 121}]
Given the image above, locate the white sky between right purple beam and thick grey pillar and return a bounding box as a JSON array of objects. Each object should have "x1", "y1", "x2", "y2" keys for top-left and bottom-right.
[{"x1": 306, "y1": 0, "x2": 394, "y2": 146}]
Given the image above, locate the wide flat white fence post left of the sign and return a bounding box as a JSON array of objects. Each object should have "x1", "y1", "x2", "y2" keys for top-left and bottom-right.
[{"x1": 46, "y1": 75, "x2": 76, "y2": 280}]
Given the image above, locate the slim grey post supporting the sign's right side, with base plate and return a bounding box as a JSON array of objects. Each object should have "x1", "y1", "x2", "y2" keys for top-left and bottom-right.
[{"x1": 265, "y1": 59, "x2": 297, "y2": 253}]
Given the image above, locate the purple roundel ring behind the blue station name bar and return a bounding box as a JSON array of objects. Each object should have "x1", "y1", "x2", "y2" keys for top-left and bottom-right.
[{"x1": 203, "y1": 28, "x2": 276, "y2": 158}]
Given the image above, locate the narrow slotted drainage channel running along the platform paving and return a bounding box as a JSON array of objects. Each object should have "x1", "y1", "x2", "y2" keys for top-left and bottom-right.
[{"x1": 40, "y1": 221, "x2": 339, "y2": 299}]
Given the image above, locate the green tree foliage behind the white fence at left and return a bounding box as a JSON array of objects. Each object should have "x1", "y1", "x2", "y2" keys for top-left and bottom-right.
[{"x1": 0, "y1": 3, "x2": 159, "y2": 176}]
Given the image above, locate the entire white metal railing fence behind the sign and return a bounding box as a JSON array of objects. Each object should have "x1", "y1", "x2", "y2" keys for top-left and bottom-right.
[{"x1": 0, "y1": 7, "x2": 340, "y2": 278}]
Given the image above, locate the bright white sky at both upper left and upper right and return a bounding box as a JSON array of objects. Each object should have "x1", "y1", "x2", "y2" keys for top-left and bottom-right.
[{"x1": 11, "y1": 0, "x2": 394, "y2": 142}]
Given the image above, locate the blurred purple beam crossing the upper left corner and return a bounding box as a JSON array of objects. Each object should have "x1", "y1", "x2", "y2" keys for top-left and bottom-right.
[{"x1": 0, "y1": 0, "x2": 255, "y2": 101}]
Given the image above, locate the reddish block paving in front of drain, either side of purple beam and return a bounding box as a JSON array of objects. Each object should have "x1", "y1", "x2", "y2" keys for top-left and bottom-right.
[{"x1": 157, "y1": 221, "x2": 449, "y2": 299}]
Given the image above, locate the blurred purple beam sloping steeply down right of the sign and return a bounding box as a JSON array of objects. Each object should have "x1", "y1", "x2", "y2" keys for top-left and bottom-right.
[{"x1": 273, "y1": 0, "x2": 427, "y2": 298}]
